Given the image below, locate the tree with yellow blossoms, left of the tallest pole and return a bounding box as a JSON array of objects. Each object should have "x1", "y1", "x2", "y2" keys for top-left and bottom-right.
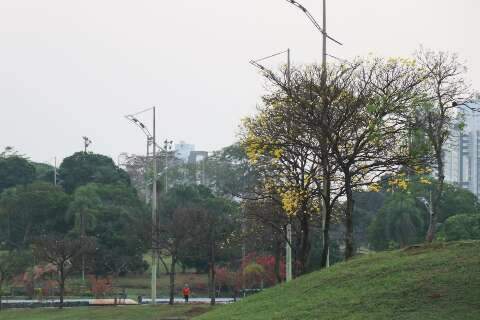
[{"x1": 242, "y1": 97, "x2": 320, "y2": 274}]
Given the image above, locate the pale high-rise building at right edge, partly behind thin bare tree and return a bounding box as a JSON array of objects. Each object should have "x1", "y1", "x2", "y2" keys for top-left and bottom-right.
[{"x1": 444, "y1": 103, "x2": 480, "y2": 197}]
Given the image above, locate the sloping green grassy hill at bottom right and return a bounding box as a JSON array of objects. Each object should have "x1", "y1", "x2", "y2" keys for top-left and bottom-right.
[{"x1": 195, "y1": 241, "x2": 480, "y2": 320}]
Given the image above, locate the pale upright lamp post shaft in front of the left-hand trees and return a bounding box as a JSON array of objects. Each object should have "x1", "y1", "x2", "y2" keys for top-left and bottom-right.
[{"x1": 150, "y1": 107, "x2": 159, "y2": 304}]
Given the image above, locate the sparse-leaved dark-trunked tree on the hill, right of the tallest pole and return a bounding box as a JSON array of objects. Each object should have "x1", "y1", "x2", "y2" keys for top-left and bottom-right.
[{"x1": 324, "y1": 59, "x2": 424, "y2": 259}]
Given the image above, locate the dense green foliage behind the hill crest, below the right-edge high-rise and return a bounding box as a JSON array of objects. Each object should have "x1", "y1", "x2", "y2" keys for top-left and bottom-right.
[{"x1": 364, "y1": 178, "x2": 480, "y2": 250}]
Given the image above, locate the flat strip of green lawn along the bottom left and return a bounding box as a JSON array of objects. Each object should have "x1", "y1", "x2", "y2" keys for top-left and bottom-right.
[{"x1": 0, "y1": 304, "x2": 210, "y2": 320}]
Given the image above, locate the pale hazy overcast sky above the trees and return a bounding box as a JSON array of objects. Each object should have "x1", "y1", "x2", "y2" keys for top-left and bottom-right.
[{"x1": 0, "y1": 0, "x2": 480, "y2": 162}]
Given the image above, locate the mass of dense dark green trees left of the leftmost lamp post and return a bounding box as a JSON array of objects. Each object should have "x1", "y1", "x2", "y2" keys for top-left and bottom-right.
[{"x1": 0, "y1": 152, "x2": 149, "y2": 275}]
